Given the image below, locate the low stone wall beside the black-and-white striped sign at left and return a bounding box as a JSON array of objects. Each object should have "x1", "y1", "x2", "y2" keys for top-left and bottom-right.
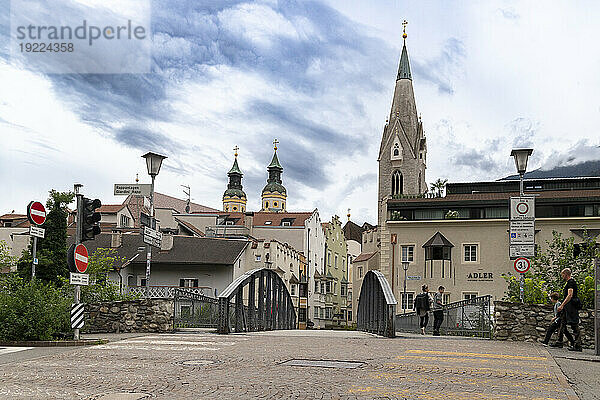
[{"x1": 83, "y1": 299, "x2": 173, "y2": 333}]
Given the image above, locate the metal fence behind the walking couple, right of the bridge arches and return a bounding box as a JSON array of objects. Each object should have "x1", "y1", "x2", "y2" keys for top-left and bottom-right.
[{"x1": 396, "y1": 295, "x2": 493, "y2": 339}]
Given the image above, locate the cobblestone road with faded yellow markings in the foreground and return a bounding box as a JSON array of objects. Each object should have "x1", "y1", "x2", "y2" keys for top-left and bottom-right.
[{"x1": 0, "y1": 331, "x2": 573, "y2": 400}]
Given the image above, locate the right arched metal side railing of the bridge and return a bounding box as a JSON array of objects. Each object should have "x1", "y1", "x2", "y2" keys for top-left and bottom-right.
[{"x1": 356, "y1": 271, "x2": 397, "y2": 338}]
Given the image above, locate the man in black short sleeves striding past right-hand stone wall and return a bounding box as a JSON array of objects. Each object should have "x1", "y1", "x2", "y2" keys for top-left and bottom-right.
[{"x1": 551, "y1": 268, "x2": 581, "y2": 351}]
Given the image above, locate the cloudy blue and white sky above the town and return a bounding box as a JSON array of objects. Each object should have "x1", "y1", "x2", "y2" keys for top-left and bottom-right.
[{"x1": 0, "y1": 0, "x2": 600, "y2": 223}]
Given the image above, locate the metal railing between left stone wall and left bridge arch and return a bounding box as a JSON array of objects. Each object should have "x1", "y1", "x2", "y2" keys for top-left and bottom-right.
[{"x1": 173, "y1": 289, "x2": 219, "y2": 329}]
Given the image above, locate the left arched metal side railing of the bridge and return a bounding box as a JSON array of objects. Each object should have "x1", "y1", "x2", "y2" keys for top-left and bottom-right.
[{"x1": 217, "y1": 268, "x2": 296, "y2": 333}]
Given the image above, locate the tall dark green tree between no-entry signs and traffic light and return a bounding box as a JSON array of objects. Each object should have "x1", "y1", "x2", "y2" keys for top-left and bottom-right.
[{"x1": 17, "y1": 190, "x2": 75, "y2": 283}]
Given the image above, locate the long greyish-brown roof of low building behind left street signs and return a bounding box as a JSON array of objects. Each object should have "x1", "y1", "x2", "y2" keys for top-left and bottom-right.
[{"x1": 68, "y1": 233, "x2": 248, "y2": 265}]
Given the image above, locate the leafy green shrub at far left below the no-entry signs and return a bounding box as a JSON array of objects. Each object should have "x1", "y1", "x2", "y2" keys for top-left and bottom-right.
[{"x1": 0, "y1": 273, "x2": 71, "y2": 340}]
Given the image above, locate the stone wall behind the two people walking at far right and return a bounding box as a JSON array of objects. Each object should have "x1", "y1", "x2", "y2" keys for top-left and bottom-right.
[{"x1": 494, "y1": 301, "x2": 594, "y2": 348}]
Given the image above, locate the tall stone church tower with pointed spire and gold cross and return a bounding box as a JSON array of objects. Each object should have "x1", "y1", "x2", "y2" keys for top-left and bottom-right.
[{"x1": 377, "y1": 21, "x2": 427, "y2": 226}]
